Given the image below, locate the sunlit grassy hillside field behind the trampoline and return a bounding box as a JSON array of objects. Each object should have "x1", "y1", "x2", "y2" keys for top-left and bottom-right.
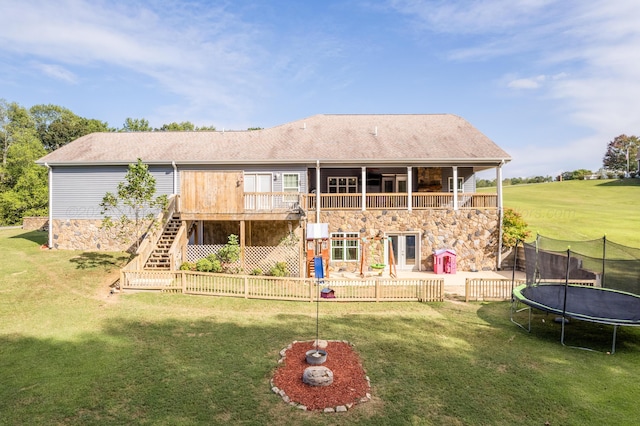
[{"x1": 479, "y1": 179, "x2": 640, "y2": 247}]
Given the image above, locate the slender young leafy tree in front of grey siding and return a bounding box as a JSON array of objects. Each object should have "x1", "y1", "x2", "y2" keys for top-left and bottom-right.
[{"x1": 100, "y1": 159, "x2": 167, "y2": 251}]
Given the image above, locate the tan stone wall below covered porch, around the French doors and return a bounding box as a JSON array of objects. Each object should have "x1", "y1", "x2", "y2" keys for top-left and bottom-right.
[{"x1": 320, "y1": 209, "x2": 499, "y2": 271}]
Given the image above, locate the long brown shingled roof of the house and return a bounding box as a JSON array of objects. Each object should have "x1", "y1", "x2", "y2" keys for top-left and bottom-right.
[{"x1": 37, "y1": 114, "x2": 511, "y2": 167}]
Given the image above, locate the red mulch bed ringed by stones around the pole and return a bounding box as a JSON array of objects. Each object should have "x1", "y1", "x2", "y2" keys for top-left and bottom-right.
[{"x1": 273, "y1": 342, "x2": 369, "y2": 410}]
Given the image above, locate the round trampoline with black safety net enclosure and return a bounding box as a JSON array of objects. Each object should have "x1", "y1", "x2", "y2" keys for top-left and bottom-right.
[{"x1": 511, "y1": 236, "x2": 640, "y2": 354}]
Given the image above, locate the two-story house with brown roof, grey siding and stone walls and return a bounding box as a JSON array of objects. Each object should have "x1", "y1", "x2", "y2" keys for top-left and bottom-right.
[{"x1": 38, "y1": 114, "x2": 510, "y2": 276}]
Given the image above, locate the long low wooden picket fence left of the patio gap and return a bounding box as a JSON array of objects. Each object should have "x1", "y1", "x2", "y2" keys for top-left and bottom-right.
[{"x1": 120, "y1": 271, "x2": 444, "y2": 302}]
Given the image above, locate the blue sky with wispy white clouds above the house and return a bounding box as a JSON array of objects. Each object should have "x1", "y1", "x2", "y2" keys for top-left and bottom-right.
[{"x1": 0, "y1": 0, "x2": 640, "y2": 178}]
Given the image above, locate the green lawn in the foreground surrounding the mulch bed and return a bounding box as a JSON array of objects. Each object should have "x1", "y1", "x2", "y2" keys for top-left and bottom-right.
[{"x1": 0, "y1": 229, "x2": 640, "y2": 425}]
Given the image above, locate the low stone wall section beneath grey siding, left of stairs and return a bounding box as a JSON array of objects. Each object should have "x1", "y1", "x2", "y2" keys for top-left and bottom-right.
[{"x1": 50, "y1": 219, "x2": 136, "y2": 251}]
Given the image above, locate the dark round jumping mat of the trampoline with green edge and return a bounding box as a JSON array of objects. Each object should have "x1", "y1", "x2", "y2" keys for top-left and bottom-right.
[{"x1": 513, "y1": 284, "x2": 640, "y2": 325}]
